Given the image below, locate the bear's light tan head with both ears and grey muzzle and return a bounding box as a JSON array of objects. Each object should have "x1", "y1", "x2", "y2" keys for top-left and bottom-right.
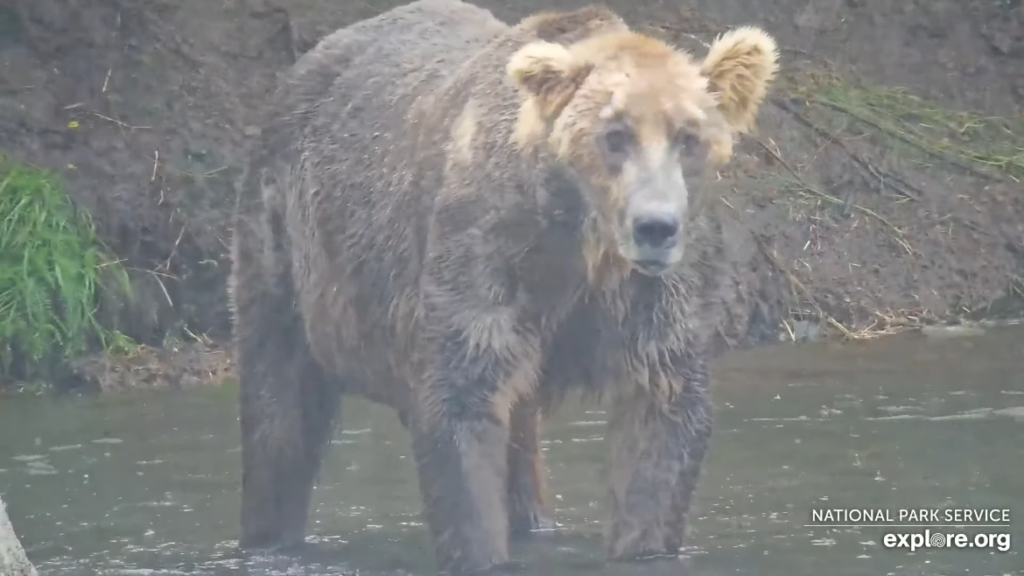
[{"x1": 507, "y1": 27, "x2": 778, "y2": 275}]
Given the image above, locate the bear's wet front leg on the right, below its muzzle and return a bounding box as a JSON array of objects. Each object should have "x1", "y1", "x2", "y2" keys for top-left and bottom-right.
[{"x1": 606, "y1": 353, "x2": 712, "y2": 561}]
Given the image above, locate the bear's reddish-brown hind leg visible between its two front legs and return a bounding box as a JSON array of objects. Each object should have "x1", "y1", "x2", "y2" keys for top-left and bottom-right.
[{"x1": 508, "y1": 400, "x2": 555, "y2": 537}]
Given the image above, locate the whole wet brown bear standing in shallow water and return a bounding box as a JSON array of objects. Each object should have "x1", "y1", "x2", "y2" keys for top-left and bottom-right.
[{"x1": 230, "y1": 0, "x2": 777, "y2": 573}]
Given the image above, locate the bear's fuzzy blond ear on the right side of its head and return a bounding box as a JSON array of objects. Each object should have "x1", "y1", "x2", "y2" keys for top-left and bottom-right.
[{"x1": 700, "y1": 27, "x2": 778, "y2": 133}]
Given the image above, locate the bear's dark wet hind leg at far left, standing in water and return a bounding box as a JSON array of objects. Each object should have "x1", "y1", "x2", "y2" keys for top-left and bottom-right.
[{"x1": 231, "y1": 208, "x2": 342, "y2": 549}]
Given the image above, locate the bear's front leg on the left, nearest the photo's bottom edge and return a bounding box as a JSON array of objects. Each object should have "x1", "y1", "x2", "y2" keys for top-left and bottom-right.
[{"x1": 412, "y1": 313, "x2": 537, "y2": 575}]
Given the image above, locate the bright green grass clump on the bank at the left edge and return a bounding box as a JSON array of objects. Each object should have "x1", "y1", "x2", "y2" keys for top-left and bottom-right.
[{"x1": 0, "y1": 156, "x2": 132, "y2": 378}]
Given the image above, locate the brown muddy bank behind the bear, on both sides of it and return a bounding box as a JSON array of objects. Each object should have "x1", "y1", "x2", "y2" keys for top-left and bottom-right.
[{"x1": 0, "y1": 0, "x2": 1024, "y2": 385}]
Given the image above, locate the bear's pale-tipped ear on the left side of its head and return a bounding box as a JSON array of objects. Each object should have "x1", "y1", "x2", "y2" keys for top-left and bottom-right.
[{"x1": 506, "y1": 41, "x2": 592, "y2": 121}]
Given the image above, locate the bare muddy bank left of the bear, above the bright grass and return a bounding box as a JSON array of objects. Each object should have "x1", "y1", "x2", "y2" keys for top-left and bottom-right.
[{"x1": 0, "y1": 0, "x2": 292, "y2": 344}]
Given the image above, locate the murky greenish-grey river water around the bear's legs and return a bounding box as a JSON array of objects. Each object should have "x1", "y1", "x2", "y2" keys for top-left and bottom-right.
[{"x1": 0, "y1": 329, "x2": 1024, "y2": 576}]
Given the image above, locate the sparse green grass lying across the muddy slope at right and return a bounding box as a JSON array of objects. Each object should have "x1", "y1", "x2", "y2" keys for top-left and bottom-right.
[{"x1": 811, "y1": 80, "x2": 1024, "y2": 181}]
